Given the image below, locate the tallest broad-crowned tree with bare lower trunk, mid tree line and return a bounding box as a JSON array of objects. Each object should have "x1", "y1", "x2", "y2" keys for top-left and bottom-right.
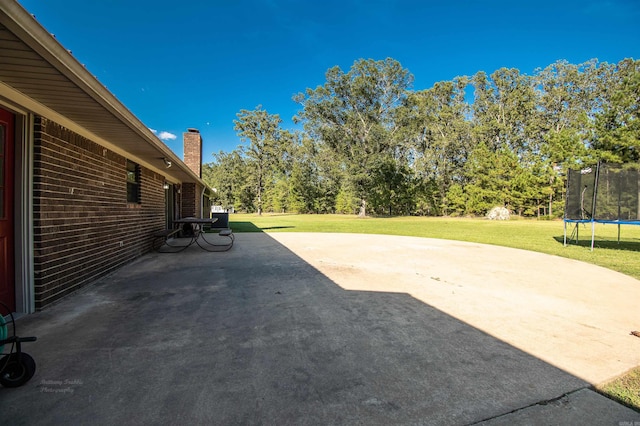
[{"x1": 294, "y1": 58, "x2": 413, "y2": 216}]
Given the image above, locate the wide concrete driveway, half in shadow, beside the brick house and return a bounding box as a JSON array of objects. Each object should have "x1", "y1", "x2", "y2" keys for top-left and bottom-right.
[{"x1": 0, "y1": 233, "x2": 640, "y2": 425}]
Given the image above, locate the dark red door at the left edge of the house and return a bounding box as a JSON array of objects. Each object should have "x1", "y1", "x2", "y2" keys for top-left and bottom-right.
[{"x1": 0, "y1": 108, "x2": 16, "y2": 315}]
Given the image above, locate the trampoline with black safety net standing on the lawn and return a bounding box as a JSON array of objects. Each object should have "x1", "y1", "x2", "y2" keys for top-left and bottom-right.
[{"x1": 564, "y1": 163, "x2": 640, "y2": 251}]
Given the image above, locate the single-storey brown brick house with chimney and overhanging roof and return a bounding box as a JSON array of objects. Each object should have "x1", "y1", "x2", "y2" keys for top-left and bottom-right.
[{"x1": 0, "y1": 0, "x2": 214, "y2": 313}]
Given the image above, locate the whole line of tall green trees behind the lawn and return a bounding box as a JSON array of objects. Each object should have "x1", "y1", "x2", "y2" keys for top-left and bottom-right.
[{"x1": 203, "y1": 58, "x2": 640, "y2": 216}]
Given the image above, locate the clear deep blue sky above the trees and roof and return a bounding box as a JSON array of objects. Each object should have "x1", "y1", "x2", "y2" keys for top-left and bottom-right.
[{"x1": 19, "y1": 0, "x2": 640, "y2": 162}]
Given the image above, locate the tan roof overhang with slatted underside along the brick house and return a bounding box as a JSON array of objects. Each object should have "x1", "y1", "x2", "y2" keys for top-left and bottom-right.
[{"x1": 0, "y1": 2, "x2": 202, "y2": 183}]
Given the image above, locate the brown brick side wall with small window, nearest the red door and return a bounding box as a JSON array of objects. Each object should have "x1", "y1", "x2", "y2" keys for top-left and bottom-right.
[{"x1": 33, "y1": 117, "x2": 165, "y2": 309}]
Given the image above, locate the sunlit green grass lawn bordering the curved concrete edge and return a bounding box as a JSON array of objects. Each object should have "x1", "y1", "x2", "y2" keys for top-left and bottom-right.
[{"x1": 229, "y1": 214, "x2": 640, "y2": 411}]
